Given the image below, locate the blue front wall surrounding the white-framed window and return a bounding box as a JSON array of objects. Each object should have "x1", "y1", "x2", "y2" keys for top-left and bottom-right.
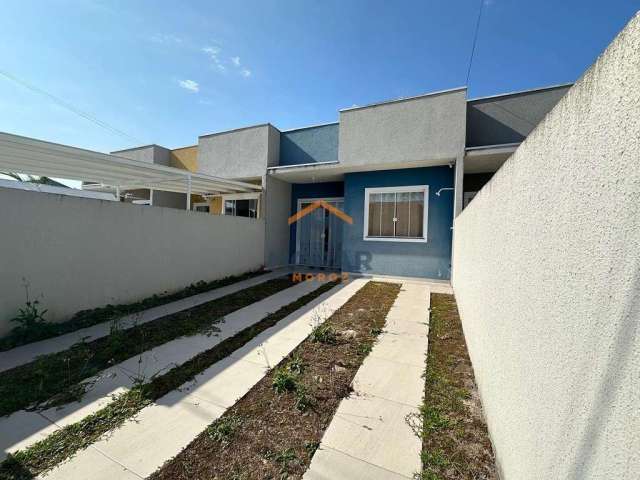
[{"x1": 342, "y1": 166, "x2": 454, "y2": 279}]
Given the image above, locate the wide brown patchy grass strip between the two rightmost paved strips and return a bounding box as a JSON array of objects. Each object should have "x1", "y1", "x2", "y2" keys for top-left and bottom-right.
[{"x1": 149, "y1": 282, "x2": 400, "y2": 480}]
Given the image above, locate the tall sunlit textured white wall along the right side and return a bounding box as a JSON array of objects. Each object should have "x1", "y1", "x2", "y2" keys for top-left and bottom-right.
[{"x1": 453, "y1": 15, "x2": 640, "y2": 480}]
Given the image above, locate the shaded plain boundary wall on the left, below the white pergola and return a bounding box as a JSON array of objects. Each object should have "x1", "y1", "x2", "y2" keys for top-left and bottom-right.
[{"x1": 0, "y1": 189, "x2": 264, "y2": 335}]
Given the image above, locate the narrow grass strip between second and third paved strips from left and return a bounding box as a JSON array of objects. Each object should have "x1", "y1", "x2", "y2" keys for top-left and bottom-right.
[{"x1": 0, "y1": 282, "x2": 338, "y2": 480}]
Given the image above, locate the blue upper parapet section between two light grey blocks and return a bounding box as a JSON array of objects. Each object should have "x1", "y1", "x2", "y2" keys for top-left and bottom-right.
[{"x1": 280, "y1": 123, "x2": 338, "y2": 165}]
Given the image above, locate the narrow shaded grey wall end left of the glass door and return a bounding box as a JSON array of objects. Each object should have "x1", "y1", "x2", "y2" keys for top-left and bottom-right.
[{"x1": 262, "y1": 175, "x2": 291, "y2": 268}]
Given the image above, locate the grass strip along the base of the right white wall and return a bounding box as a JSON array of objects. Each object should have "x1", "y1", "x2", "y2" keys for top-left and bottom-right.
[{"x1": 407, "y1": 293, "x2": 498, "y2": 480}]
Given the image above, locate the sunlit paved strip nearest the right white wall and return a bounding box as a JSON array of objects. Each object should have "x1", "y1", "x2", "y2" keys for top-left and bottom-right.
[{"x1": 303, "y1": 282, "x2": 430, "y2": 480}]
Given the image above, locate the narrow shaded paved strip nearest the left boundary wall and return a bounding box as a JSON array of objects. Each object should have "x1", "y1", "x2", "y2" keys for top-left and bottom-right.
[{"x1": 0, "y1": 270, "x2": 287, "y2": 372}]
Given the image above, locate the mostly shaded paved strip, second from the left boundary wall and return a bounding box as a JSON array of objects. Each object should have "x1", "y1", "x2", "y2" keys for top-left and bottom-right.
[{"x1": 0, "y1": 282, "x2": 320, "y2": 460}]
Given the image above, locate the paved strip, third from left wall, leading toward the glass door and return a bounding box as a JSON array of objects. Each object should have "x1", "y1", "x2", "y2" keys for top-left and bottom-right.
[{"x1": 44, "y1": 279, "x2": 367, "y2": 480}]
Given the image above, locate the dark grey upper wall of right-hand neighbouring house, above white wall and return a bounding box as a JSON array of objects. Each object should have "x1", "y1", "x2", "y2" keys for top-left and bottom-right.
[{"x1": 467, "y1": 86, "x2": 570, "y2": 147}]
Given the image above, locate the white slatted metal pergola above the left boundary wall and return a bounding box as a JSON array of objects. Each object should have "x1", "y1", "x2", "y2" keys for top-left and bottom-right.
[{"x1": 0, "y1": 132, "x2": 262, "y2": 210}]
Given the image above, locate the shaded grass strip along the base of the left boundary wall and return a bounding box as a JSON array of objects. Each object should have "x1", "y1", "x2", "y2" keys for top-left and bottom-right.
[{"x1": 0, "y1": 270, "x2": 267, "y2": 352}]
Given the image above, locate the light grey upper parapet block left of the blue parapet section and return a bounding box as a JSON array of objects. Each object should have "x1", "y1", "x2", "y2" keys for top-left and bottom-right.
[{"x1": 198, "y1": 124, "x2": 280, "y2": 179}]
